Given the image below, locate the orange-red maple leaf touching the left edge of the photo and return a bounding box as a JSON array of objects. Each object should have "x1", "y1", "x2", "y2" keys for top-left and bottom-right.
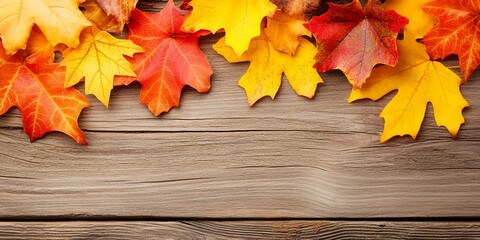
[{"x1": 0, "y1": 39, "x2": 89, "y2": 144}]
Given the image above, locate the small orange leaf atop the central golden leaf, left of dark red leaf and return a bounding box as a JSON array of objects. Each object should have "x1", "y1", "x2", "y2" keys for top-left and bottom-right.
[{"x1": 265, "y1": 11, "x2": 311, "y2": 55}]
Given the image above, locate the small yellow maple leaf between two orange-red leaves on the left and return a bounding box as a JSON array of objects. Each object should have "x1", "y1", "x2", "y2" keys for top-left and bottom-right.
[{"x1": 61, "y1": 27, "x2": 143, "y2": 107}]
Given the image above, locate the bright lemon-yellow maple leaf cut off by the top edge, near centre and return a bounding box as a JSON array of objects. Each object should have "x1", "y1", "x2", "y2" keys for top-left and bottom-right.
[{"x1": 182, "y1": 0, "x2": 276, "y2": 56}]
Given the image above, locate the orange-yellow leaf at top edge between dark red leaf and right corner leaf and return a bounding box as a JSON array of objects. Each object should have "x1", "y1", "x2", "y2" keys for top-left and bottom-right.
[{"x1": 383, "y1": 0, "x2": 437, "y2": 39}]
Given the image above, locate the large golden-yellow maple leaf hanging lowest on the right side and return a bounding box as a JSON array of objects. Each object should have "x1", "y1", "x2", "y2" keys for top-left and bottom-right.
[{"x1": 349, "y1": 32, "x2": 468, "y2": 142}]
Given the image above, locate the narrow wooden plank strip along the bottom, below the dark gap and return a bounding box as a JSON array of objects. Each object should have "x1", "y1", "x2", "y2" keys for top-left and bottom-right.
[{"x1": 0, "y1": 221, "x2": 480, "y2": 240}]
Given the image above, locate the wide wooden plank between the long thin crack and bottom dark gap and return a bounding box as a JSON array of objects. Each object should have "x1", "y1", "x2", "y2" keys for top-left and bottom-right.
[{"x1": 0, "y1": 129, "x2": 480, "y2": 218}]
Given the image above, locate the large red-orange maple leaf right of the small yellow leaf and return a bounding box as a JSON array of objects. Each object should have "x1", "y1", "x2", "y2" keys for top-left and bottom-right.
[{"x1": 116, "y1": 0, "x2": 213, "y2": 116}]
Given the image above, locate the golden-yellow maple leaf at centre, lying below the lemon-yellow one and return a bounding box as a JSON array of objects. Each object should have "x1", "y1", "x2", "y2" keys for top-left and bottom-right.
[{"x1": 213, "y1": 30, "x2": 323, "y2": 106}]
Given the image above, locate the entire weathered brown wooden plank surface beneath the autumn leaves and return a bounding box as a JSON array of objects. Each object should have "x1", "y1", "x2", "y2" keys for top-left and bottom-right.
[{"x1": 0, "y1": 1, "x2": 480, "y2": 239}]
